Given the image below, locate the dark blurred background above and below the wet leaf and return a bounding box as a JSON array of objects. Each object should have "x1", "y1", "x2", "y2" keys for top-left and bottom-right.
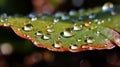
[{"x1": 0, "y1": 0, "x2": 120, "y2": 67}]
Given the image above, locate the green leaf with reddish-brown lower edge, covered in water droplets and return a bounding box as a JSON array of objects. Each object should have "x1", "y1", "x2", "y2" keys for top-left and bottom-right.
[{"x1": 0, "y1": 7, "x2": 120, "y2": 52}]
